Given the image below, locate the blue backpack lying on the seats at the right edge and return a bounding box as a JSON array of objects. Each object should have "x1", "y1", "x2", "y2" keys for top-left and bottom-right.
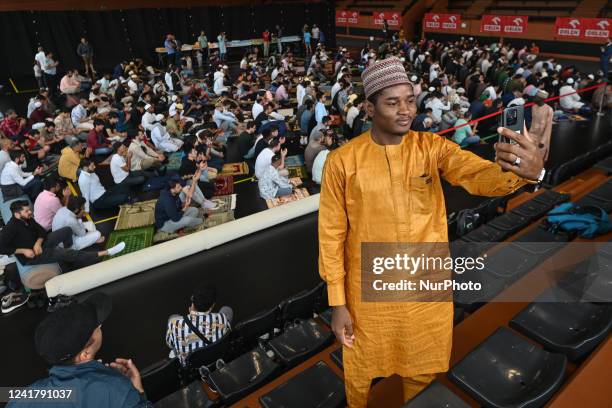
[{"x1": 547, "y1": 203, "x2": 612, "y2": 238}]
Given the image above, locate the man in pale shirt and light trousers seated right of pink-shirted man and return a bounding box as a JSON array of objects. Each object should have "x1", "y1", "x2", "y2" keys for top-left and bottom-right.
[{"x1": 51, "y1": 196, "x2": 104, "y2": 251}]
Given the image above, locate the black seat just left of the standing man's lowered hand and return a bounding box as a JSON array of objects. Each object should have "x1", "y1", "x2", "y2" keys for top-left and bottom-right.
[{"x1": 267, "y1": 319, "x2": 334, "y2": 367}]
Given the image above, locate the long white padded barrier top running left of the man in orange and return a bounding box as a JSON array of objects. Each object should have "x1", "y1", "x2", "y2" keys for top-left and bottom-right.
[{"x1": 45, "y1": 194, "x2": 319, "y2": 297}]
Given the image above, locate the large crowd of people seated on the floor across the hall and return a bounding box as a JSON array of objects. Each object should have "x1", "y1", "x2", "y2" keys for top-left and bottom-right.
[{"x1": 0, "y1": 23, "x2": 612, "y2": 318}]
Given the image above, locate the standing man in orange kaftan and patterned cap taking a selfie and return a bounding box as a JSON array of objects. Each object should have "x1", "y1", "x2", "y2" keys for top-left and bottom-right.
[{"x1": 319, "y1": 58, "x2": 543, "y2": 408}]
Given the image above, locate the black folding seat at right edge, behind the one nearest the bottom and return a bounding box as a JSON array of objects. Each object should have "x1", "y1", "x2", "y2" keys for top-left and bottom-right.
[{"x1": 510, "y1": 288, "x2": 612, "y2": 361}]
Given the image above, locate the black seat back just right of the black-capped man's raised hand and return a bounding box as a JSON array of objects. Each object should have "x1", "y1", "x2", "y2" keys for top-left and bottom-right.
[{"x1": 140, "y1": 358, "x2": 181, "y2": 402}]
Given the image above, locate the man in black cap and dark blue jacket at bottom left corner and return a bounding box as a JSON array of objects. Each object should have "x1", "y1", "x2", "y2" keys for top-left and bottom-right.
[{"x1": 7, "y1": 293, "x2": 153, "y2": 408}]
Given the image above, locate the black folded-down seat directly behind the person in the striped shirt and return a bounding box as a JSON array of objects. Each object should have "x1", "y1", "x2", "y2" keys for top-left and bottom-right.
[{"x1": 200, "y1": 347, "x2": 280, "y2": 404}]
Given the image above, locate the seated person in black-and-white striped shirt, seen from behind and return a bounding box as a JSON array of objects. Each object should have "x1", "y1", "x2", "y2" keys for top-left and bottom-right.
[{"x1": 166, "y1": 285, "x2": 234, "y2": 365}]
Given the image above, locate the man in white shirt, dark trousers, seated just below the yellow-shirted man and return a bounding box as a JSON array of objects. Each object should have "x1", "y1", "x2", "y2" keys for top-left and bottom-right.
[{"x1": 79, "y1": 158, "x2": 130, "y2": 211}]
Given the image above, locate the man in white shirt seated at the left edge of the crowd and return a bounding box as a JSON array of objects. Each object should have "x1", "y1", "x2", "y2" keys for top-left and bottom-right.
[{"x1": 0, "y1": 150, "x2": 43, "y2": 202}]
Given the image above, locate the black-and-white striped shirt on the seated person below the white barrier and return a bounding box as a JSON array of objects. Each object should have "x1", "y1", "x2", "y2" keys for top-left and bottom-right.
[{"x1": 166, "y1": 312, "x2": 230, "y2": 365}]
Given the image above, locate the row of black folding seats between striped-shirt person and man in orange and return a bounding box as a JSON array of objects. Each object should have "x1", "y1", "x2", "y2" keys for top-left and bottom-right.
[{"x1": 142, "y1": 283, "x2": 334, "y2": 405}]
